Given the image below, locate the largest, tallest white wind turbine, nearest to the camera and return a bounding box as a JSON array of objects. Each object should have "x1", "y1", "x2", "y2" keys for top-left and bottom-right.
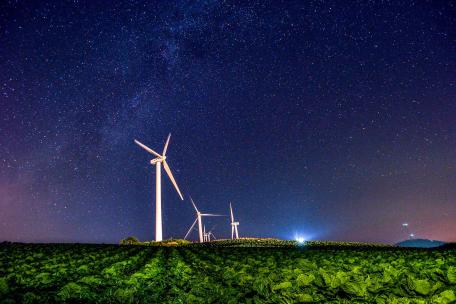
[{"x1": 135, "y1": 133, "x2": 184, "y2": 242}]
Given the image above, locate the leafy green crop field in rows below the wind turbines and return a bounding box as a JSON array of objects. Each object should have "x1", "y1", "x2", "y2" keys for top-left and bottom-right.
[{"x1": 0, "y1": 243, "x2": 456, "y2": 303}]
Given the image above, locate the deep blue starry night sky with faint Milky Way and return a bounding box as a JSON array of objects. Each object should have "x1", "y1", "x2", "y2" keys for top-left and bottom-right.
[{"x1": 0, "y1": 1, "x2": 456, "y2": 243}]
